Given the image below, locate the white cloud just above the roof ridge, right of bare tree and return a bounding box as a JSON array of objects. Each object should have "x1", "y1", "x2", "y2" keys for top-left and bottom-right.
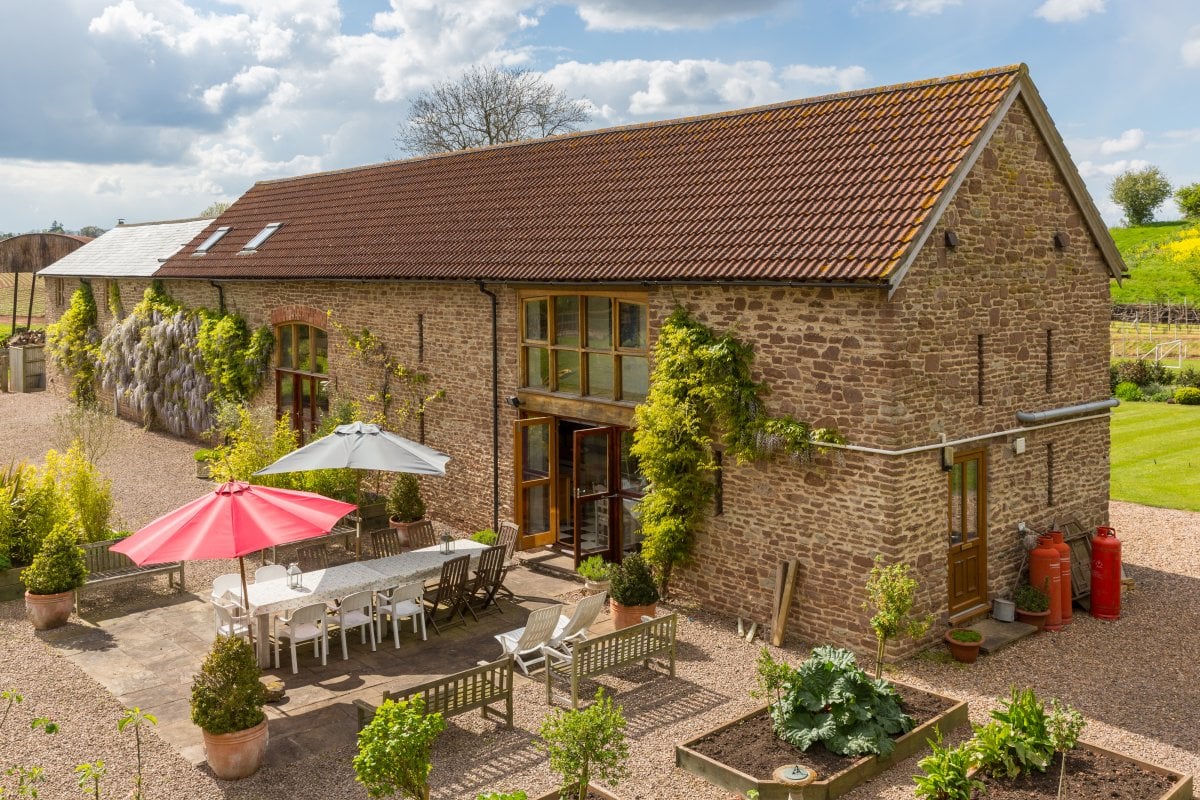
[{"x1": 546, "y1": 59, "x2": 868, "y2": 125}]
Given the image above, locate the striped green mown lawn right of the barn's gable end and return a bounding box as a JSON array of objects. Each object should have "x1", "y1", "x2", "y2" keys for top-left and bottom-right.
[{"x1": 1109, "y1": 403, "x2": 1200, "y2": 511}]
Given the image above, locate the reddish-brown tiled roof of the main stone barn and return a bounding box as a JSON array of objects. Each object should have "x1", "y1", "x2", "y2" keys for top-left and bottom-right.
[{"x1": 157, "y1": 65, "x2": 1122, "y2": 288}]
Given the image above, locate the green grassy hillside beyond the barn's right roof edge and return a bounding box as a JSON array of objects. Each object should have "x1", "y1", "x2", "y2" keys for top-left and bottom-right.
[{"x1": 1109, "y1": 221, "x2": 1200, "y2": 306}]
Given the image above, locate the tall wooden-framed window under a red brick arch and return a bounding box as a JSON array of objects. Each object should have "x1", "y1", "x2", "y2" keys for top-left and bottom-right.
[{"x1": 275, "y1": 323, "x2": 329, "y2": 433}]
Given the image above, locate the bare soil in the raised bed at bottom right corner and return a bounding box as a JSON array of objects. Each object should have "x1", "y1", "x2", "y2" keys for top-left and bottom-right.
[{"x1": 974, "y1": 750, "x2": 1175, "y2": 800}]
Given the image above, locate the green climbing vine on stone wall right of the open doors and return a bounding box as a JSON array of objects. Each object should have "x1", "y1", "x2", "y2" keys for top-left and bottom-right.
[{"x1": 632, "y1": 308, "x2": 845, "y2": 596}]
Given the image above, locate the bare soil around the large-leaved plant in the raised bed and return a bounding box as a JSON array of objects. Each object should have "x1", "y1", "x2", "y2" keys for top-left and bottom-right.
[{"x1": 692, "y1": 686, "x2": 954, "y2": 780}]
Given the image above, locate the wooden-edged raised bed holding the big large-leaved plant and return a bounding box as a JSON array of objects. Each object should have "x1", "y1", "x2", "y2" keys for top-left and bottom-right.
[{"x1": 676, "y1": 684, "x2": 967, "y2": 800}]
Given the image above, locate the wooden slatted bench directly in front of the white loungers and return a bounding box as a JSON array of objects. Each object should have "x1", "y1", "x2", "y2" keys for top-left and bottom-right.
[{"x1": 541, "y1": 614, "x2": 676, "y2": 709}]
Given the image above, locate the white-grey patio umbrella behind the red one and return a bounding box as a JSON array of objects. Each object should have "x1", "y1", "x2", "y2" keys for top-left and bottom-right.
[{"x1": 254, "y1": 422, "x2": 450, "y2": 556}]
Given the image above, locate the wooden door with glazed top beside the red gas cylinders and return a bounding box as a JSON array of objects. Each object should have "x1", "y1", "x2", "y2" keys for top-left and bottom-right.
[{"x1": 948, "y1": 450, "x2": 988, "y2": 616}]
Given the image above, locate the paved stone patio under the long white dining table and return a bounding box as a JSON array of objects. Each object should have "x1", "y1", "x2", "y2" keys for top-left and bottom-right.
[{"x1": 44, "y1": 556, "x2": 592, "y2": 766}]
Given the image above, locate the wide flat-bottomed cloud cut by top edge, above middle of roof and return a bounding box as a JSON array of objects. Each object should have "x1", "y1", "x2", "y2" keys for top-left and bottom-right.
[{"x1": 576, "y1": 0, "x2": 787, "y2": 31}]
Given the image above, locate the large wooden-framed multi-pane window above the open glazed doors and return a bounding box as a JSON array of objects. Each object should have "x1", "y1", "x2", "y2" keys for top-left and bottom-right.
[{"x1": 521, "y1": 294, "x2": 650, "y2": 403}]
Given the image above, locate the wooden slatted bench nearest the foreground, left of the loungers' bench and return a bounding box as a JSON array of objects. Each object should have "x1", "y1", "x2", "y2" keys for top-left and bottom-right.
[{"x1": 354, "y1": 656, "x2": 512, "y2": 730}]
